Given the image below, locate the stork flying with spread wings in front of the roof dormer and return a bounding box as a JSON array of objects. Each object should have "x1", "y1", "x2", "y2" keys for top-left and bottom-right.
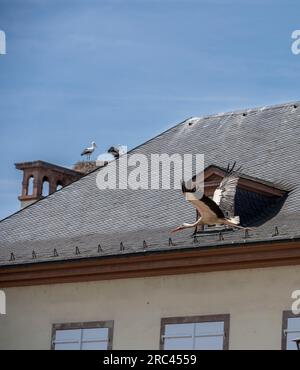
[{"x1": 172, "y1": 163, "x2": 249, "y2": 232}]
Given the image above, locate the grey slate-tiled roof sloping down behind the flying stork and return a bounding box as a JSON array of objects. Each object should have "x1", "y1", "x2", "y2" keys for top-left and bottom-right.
[{"x1": 0, "y1": 102, "x2": 300, "y2": 266}]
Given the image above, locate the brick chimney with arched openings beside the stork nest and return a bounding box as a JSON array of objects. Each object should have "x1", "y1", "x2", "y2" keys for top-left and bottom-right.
[{"x1": 15, "y1": 161, "x2": 83, "y2": 208}]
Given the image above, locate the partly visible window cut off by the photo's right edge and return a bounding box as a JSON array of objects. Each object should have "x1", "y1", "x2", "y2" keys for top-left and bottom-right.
[{"x1": 281, "y1": 311, "x2": 300, "y2": 350}]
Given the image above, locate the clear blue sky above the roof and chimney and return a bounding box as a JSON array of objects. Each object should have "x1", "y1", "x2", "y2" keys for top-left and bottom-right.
[{"x1": 0, "y1": 0, "x2": 300, "y2": 219}]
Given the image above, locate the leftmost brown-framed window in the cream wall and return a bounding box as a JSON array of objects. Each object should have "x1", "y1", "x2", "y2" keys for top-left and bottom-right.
[{"x1": 51, "y1": 321, "x2": 114, "y2": 350}]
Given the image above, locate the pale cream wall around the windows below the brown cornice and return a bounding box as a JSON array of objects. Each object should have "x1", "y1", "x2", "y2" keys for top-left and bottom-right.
[{"x1": 0, "y1": 266, "x2": 300, "y2": 350}]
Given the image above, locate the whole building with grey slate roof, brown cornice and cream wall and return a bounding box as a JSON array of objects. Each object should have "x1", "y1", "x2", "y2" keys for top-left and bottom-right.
[{"x1": 0, "y1": 103, "x2": 300, "y2": 350}]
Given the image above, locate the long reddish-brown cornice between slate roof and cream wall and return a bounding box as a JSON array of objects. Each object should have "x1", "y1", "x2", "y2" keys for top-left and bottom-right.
[{"x1": 0, "y1": 240, "x2": 300, "y2": 288}]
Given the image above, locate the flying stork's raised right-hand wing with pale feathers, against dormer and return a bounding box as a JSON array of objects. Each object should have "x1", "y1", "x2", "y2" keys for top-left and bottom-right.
[{"x1": 213, "y1": 162, "x2": 240, "y2": 218}]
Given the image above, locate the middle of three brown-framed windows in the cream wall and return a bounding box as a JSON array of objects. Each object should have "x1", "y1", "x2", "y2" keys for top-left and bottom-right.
[{"x1": 160, "y1": 315, "x2": 230, "y2": 350}]
